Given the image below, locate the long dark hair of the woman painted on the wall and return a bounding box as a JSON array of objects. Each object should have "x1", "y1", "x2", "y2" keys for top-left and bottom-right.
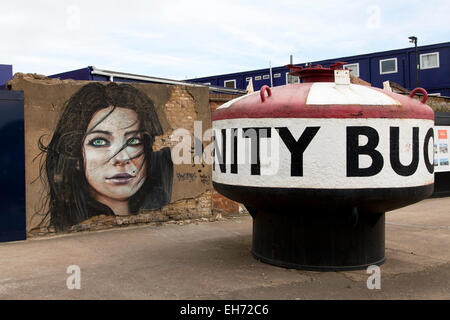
[{"x1": 39, "y1": 82, "x2": 173, "y2": 231}]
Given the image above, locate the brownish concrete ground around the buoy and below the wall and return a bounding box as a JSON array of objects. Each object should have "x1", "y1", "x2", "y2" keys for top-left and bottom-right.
[{"x1": 0, "y1": 197, "x2": 450, "y2": 300}]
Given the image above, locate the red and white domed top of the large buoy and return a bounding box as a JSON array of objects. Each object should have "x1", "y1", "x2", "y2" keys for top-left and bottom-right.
[{"x1": 213, "y1": 62, "x2": 434, "y2": 121}]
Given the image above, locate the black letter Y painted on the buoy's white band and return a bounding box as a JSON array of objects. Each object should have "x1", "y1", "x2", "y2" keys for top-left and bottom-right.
[{"x1": 276, "y1": 127, "x2": 320, "y2": 177}]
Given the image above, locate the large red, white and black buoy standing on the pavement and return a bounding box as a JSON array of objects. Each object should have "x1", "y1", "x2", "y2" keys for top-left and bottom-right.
[{"x1": 213, "y1": 70, "x2": 434, "y2": 270}]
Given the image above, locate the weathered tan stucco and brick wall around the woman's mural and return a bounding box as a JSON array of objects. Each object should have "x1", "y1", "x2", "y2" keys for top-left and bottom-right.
[{"x1": 8, "y1": 74, "x2": 211, "y2": 234}]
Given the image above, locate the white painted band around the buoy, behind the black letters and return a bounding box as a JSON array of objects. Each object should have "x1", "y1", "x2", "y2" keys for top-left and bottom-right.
[{"x1": 213, "y1": 118, "x2": 434, "y2": 189}]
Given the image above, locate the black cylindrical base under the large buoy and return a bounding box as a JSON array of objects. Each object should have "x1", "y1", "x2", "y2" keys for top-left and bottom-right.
[{"x1": 248, "y1": 208, "x2": 385, "y2": 271}]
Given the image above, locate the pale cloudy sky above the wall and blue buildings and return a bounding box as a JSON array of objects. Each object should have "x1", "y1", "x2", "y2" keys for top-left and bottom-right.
[{"x1": 0, "y1": 0, "x2": 450, "y2": 80}]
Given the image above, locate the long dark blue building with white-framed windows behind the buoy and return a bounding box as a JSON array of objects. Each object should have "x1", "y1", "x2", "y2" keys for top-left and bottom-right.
[{"x1": 186, "y1": 42, "x2": 450, "y2": 96}]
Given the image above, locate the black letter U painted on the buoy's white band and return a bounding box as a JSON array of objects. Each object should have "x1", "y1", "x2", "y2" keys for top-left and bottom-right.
[{"x1": 389, "y1": 127, "x2": 419, "y2": 177}]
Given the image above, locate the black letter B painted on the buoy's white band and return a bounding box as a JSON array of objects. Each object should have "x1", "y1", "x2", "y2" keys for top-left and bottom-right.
[{"x1": 347, "y1": 126, "x2": 384, "y2": 177}]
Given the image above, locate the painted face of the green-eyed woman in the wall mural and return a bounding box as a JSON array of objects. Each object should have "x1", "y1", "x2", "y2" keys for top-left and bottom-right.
[{"x1": 83, "y1": 107, "x2": 146, "y2": 201}]
